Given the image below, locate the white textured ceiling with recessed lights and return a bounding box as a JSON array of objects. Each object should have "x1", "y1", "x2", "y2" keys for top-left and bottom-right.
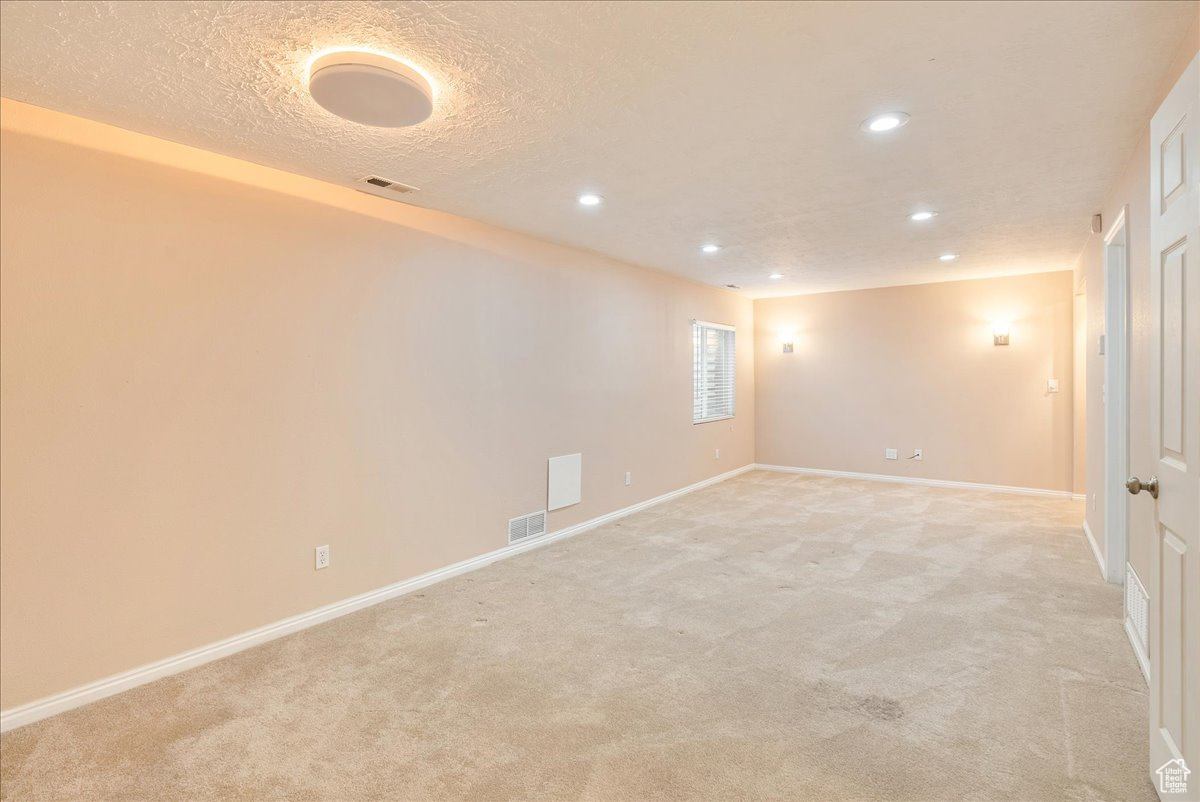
[{"x1": 0, "y1": 0, "x2": 1198, "y2": 297}]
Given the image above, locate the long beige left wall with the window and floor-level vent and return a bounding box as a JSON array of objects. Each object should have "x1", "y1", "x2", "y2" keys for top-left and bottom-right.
[{"x1": 0, "y1": 101, "x2": 755, "y2": 708}]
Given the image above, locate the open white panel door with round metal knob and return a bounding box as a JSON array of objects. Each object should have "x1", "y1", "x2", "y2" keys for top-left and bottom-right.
[{"x1": 1130, "y1": 56, "x2": 1200, "y2": 800}]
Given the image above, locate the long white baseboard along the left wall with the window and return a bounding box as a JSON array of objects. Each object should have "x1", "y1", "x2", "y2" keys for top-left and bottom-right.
[{"x1": 0, "y1": 465, "x2": 755, "y2": 732}]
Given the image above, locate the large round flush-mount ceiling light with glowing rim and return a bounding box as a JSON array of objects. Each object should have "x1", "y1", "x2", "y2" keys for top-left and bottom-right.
[{"x1": 308, "y1": 50, "x2": 433, "y2": 128}]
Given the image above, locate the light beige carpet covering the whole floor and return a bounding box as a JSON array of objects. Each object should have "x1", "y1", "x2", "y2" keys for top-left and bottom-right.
[{"x1": 0, "y1": 472, "x2": 1154, "y2": 802}]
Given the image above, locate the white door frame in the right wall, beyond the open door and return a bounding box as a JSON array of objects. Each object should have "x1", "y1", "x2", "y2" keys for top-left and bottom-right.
[{"x1": 1103, "y1": 205, "x2": 1129, "y2": 585}]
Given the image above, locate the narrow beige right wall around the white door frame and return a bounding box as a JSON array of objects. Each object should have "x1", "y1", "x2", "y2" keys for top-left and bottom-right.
[{"x1": 1075, "y1": 21, "x2": 1200, "y2": 583}]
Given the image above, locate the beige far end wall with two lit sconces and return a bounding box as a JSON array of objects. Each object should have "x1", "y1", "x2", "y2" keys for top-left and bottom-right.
[{"x1": 755, "y1": 273, "x2": 1073, "y2": 491}]
